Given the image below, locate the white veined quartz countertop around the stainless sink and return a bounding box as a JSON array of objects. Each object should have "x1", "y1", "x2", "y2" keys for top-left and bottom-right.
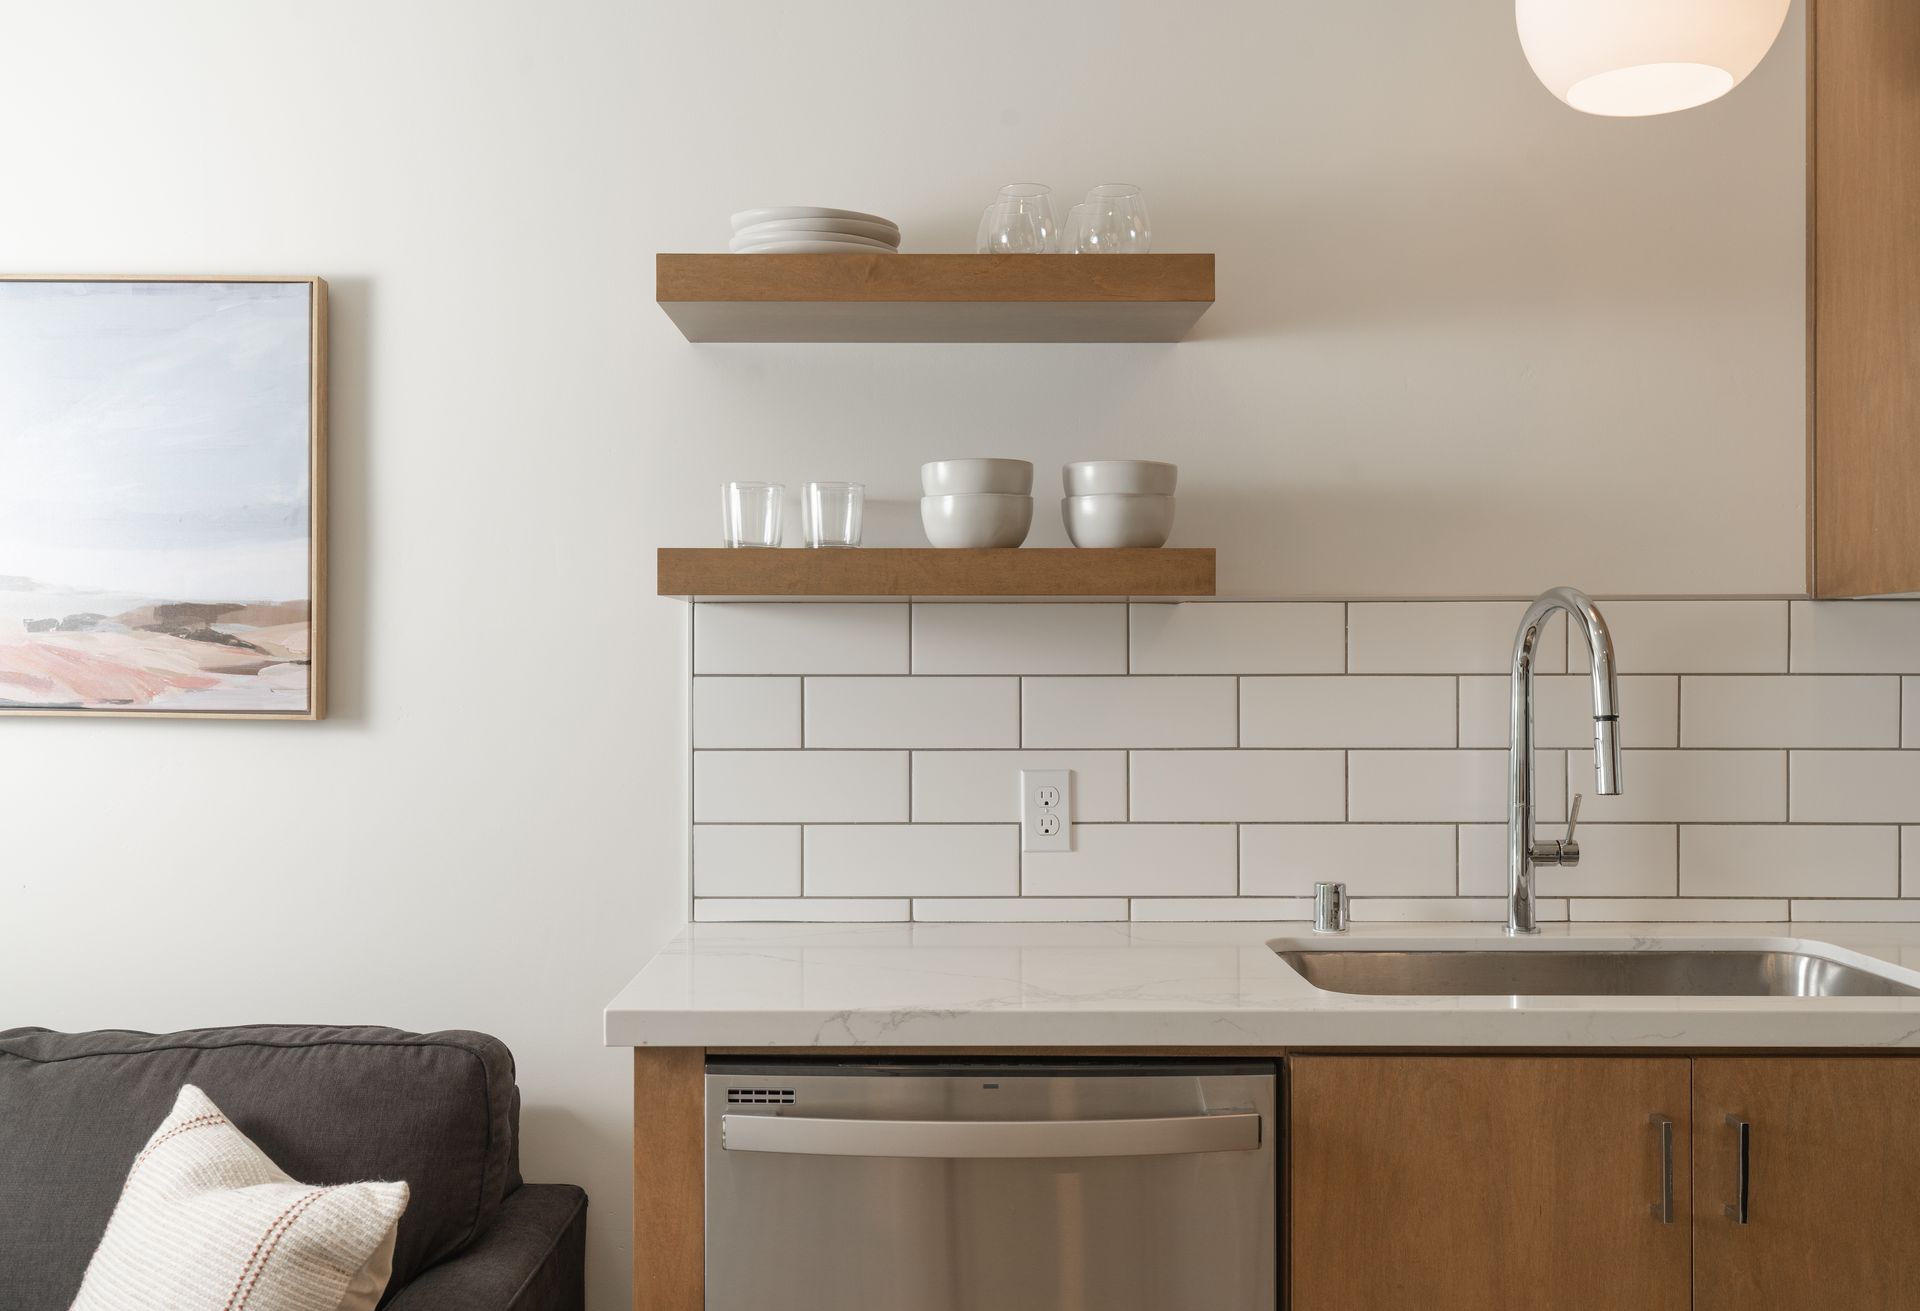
[{"x1": 607, "y1": 921, "x2": 1920, "y2": 1050}]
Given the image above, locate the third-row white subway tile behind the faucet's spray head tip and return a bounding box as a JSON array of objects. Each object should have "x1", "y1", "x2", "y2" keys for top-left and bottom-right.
[{"x1": 1567, "y1": 751, "x2": 1788, "y2": 823}]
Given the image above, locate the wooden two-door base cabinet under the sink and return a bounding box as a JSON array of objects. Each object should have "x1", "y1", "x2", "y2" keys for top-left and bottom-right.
[{"x1": 1286, "y1": 1056, "x2": 1920, "y2": 1311}]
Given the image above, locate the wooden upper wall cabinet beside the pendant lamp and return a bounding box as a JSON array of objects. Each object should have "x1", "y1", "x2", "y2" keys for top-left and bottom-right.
[{"x1": 1807, "y1": 0, "x2": 1920, "y2": 595}]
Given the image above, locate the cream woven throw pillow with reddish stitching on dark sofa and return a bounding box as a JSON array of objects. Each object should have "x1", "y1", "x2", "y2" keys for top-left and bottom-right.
[{"x1": 73, "y1": 1085, "x2": 407, "y2": 1311}]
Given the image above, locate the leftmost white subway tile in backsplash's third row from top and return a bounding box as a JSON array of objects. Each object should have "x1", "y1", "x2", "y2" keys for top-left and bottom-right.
[{"x1": 693, "y1": 751, "x2": 908, "y2": 823}]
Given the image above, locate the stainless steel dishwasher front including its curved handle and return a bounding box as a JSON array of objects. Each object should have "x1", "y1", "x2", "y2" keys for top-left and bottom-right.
[{"x1": 706, "y1": 1060, "x2": 1279, "y2": 1311}]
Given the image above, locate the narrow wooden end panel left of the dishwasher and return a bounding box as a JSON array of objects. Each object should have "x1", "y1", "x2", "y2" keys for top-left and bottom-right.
[{"x1": 634, "y1": 1046, "x2": 707, "y2": 1311}]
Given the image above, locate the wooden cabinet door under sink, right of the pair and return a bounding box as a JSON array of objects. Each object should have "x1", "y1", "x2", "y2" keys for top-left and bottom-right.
[{"x1": 1693, "y1": 1056, "x2": 1920, "y2": 1311}]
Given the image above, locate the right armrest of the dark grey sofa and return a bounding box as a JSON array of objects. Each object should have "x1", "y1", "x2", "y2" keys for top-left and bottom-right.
[{"x1": 384, "y1": 1184, "x2": 588, "y2": 1311}]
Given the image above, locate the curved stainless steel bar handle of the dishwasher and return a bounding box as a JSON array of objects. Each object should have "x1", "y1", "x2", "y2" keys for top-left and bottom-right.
[{"x1": 720, "y1": 1111, "x2": 1260, "y2": 1159}]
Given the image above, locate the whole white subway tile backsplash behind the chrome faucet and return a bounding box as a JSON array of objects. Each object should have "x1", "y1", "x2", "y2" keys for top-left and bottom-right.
[{"x1": 687, "y1": 599, "x2": 1920, "y2": 933}]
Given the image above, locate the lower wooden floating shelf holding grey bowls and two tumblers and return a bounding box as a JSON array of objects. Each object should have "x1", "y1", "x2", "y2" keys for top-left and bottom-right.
[{"x1": 659, "y1": 547, "x2": 1213, "y2": 601}]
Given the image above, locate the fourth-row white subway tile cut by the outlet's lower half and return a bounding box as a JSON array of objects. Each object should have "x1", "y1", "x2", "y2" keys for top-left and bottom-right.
[{"x1": 1021, "y1": 823, "x2": 1238, "y2": 896}]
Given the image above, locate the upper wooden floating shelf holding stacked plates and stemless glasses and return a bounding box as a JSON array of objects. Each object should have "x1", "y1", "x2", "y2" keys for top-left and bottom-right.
[{"x1": 653, "y1": 253, "x2": 1213, "y2": 342}]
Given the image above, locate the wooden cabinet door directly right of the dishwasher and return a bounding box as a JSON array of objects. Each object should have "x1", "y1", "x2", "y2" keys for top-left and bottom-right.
[{"x1": 1286, "y1": 1056, "x2": 1692, "y2": 1311}]
